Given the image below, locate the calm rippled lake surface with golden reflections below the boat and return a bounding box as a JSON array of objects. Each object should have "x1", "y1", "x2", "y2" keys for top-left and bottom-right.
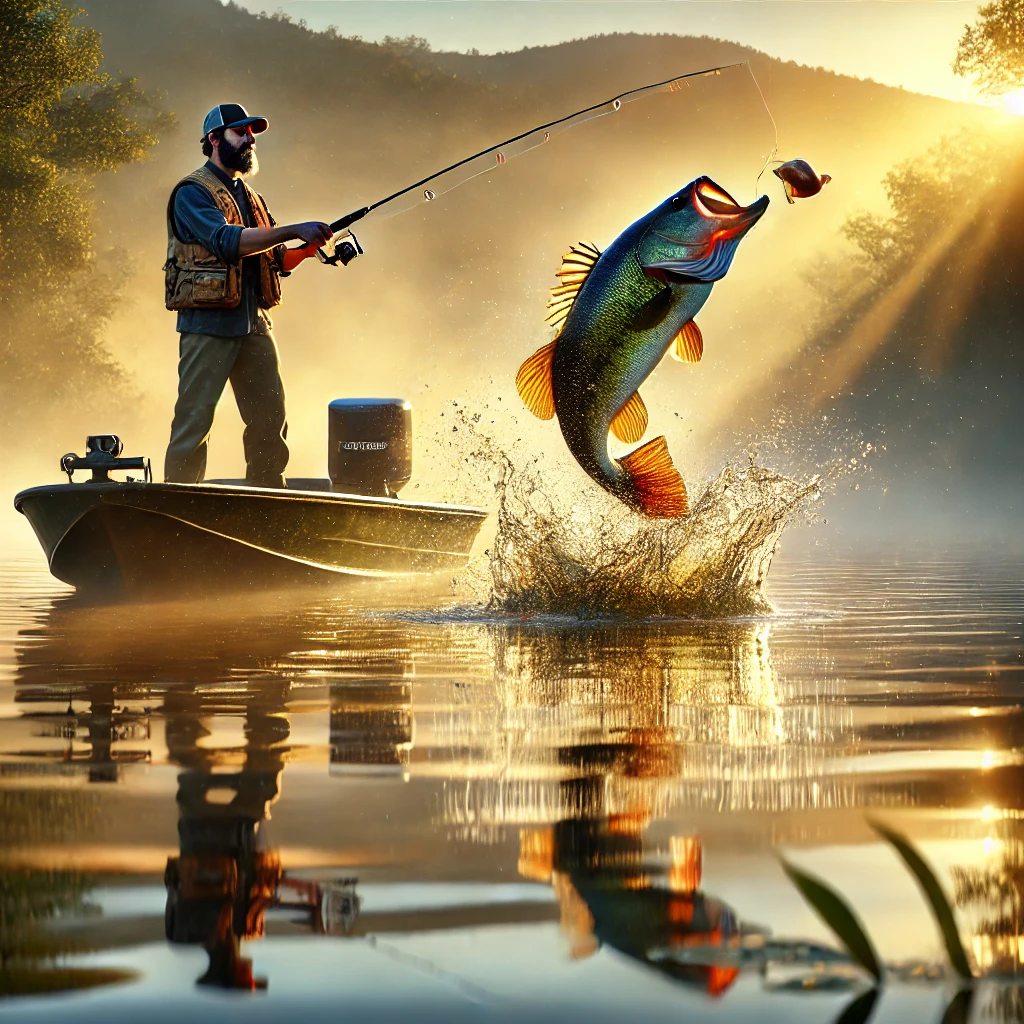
[{"x1": 0, "y1": 557, "x2": 1024, "y2": 1024}]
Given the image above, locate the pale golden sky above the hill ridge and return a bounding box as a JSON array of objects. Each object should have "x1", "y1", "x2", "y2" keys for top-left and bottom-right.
[{"x1": 239, "y1": 0, "x2": 978, "y2": 100}]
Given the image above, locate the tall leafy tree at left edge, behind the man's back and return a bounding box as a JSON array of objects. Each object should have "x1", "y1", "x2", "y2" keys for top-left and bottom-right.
[{"x1": 0, "y1": 0, "x2": 173, "y2": 427}]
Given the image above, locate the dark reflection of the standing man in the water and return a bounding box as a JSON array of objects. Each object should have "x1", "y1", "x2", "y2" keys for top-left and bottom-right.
[{"x1": 157, "y1": 681, "x2": 337, "y2": 989}]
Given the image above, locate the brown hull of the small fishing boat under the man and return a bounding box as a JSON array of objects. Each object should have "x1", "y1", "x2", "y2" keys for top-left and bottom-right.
[{"x1": 14, "y1": 481, "x2": 486, "y2": 592}]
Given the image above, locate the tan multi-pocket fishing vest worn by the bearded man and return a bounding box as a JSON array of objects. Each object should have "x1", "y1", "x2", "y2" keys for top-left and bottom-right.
[{"x1": 164, "y1": 167, "x2": 284, "y2": 309}]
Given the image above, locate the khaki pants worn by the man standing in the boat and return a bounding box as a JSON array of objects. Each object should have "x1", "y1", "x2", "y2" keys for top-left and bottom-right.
[{"x1": 164, "y1": 334, "x2": 288, "y2": 487}]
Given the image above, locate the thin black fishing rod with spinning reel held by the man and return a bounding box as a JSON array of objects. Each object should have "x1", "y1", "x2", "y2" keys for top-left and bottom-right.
[{"x1": 316, "y1": 60, "x2": 749, "y2": 266}]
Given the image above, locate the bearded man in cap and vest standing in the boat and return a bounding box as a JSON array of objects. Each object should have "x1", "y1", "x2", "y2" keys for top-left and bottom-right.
[{"x1": 164, "y1": 103, "x2": 332, "y2": 487}]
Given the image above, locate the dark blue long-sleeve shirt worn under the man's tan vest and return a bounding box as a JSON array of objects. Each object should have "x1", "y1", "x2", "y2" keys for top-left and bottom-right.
[{"x1": 174, "y1": 161, "x2": 276, "y2": 338}]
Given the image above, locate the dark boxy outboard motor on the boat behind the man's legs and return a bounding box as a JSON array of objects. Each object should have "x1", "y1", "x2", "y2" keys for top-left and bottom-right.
[{"x1": 328, "y1": 398, "x2": 413, "y2": 498}]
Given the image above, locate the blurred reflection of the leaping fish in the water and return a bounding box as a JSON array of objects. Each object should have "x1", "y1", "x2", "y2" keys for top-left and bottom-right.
[{"x1": 519, "y1": 757, "x2": 740, "y2": 996}]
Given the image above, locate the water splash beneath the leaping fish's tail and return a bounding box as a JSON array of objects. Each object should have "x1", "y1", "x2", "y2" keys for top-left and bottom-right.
[{"x1": 488, "y1": 455, "x2": 820, "y2": 617}]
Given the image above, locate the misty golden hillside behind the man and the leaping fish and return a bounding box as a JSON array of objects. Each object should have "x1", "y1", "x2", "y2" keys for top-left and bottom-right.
[{"x1": 58, "y1": 0, "x2": 999, "y2": 520}]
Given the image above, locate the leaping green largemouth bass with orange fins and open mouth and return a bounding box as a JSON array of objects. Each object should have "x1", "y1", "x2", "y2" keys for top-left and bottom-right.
[{"x1": 516, "y1": 177, "x2": 768, "y2": 518}]
